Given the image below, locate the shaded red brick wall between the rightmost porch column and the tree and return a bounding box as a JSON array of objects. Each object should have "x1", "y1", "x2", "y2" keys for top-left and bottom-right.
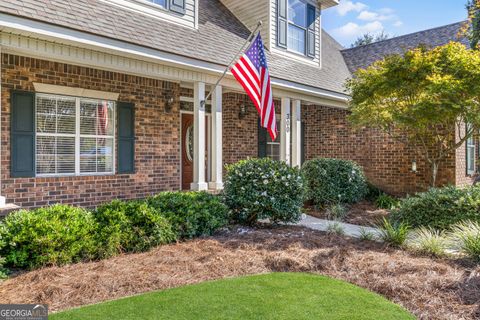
[{"x1": 302, "y1": 105, "x2": 455, "y2": 194}]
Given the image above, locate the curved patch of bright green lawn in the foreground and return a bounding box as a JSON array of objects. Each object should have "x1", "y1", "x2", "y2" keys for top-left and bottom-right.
[{"x1": 51, "y1": 273, "x2": 414, "y2": 320}]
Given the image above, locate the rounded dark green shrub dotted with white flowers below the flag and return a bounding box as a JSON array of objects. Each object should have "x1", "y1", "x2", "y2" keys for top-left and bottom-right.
[{"x1": 224, "y1": 158, "x2": 304, "y2": 224}]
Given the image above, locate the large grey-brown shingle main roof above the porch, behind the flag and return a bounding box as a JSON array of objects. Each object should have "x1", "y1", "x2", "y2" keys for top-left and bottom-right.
[{"x1": 0, "y1": 0, "x2": 350, "y2": 93}]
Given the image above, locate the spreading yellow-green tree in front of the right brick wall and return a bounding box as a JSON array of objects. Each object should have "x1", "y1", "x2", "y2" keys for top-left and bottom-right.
[{"x1": 346, "y1": 42, "x2": 480, "y2": 186}]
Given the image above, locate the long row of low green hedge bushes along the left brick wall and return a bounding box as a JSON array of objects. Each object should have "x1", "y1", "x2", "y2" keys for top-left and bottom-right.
[{"x1": 0, "y1": 192, "x2": 228, "y2": 272}]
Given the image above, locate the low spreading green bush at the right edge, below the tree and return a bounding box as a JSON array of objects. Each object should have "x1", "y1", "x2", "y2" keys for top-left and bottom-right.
[{"x1": 393, "y1": 186, "x2": 480, "y2": 230}]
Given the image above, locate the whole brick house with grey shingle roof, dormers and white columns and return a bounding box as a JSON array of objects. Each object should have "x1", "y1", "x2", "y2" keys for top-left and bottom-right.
[{"x1": 0, "y1": 0, "x2": 470, "y2": 208}]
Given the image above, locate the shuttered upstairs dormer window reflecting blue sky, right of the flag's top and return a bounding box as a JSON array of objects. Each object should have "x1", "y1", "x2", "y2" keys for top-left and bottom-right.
[{"x1": 277, "y1": 0, "x2": 317, "y2": 58}]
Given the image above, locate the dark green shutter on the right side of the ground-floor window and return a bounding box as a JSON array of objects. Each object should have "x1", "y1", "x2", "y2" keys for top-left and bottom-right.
[{"x1": 117, "y1": 102, "x2": 135, "y2": 173}]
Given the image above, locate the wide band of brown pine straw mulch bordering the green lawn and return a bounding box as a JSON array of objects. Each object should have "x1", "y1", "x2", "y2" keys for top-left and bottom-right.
[{"x1": 0, "y1": 227, "x2": 480, "y2": 319}]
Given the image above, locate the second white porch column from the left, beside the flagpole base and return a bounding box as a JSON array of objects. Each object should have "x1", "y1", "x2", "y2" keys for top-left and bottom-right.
[{"x1": 208, "y1": 86, "x2": 223, "y2": 190}]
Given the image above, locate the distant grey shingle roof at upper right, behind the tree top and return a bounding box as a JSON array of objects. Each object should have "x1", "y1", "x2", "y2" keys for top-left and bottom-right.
[{"x1": 342, "y1": 22, "x2": 468, "y2": 73}]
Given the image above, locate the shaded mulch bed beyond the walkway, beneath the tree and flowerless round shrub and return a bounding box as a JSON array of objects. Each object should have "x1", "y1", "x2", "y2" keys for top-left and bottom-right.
[{"x1": 305, "y1": 201, "x2": 388, "y2": 227}]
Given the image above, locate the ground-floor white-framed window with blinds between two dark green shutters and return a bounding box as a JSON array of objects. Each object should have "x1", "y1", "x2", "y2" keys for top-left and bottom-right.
[{"x1": 36, "y1": 94, "x2": 115, "y2": 176}]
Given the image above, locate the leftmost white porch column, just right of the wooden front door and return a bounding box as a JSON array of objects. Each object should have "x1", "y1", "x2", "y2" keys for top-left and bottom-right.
[{"x1": 190, "y1": 82, "x2": 208, "y2": 191}]
